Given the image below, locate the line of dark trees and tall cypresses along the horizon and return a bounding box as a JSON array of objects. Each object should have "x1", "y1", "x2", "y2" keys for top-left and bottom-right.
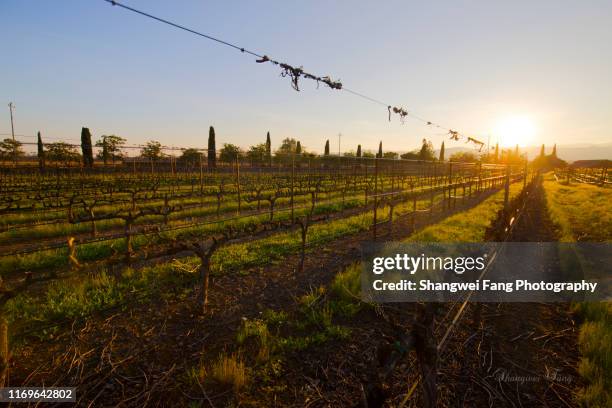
[{"x1": 0, "y1": 126, "x2": 552, "y2": 168}]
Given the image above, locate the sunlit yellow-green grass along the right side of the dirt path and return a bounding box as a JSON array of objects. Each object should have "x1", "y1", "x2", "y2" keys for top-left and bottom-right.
[{"x1": 544, "y1": 173, "x2": 612, "y2": 408}]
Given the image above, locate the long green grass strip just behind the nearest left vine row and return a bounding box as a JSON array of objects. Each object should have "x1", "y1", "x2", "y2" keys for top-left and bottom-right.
[{"x1": 5, "y1": 190, "x2": 440, "y2": 336}]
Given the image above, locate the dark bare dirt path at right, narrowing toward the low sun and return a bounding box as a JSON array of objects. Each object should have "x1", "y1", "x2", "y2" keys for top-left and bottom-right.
[{"x1": 442, "y1": 177, "x2": 580, "y2": 407}]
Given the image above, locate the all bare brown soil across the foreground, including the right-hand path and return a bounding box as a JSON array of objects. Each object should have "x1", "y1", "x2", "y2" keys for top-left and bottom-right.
[{"x1": 10, "y1": 183, "x2": 579, "y2": 407}]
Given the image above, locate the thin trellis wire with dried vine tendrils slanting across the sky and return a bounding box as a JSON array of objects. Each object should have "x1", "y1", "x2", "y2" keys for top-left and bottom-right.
[{"x1": 104, "y1": 0, "x2": 488, "y2": 148}]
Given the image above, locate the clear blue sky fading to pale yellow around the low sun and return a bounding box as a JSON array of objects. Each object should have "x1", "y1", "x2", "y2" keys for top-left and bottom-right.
[{"x1": 0, "y1": 0, "x2": 612, "y2": 152}]
